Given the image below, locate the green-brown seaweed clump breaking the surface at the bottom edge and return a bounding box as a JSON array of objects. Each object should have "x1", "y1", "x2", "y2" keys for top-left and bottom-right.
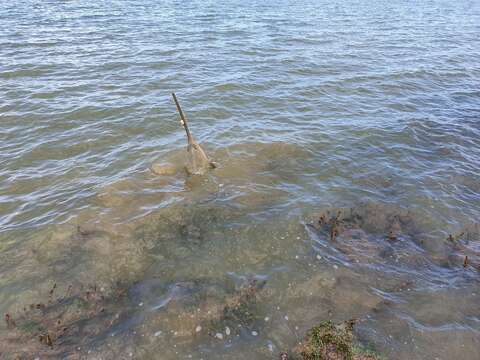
[{"x1": 296, "y1": 320, "x2": 380, "y2": 360}]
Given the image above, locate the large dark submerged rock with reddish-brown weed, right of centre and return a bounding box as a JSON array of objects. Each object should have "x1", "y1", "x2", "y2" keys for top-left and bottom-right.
[{"x1": 308, "y1": 203, "x2": 438, "y2": 268}]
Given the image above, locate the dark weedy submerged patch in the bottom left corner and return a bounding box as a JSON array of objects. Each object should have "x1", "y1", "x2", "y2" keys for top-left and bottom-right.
[{"x1": 0, "y1": 284, "x2": 127, "y2": 359}]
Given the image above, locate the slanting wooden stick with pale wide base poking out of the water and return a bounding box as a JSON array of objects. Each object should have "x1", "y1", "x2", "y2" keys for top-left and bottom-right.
[{"x1": 172, "y1": 93, "x2": 215, "y2": 175}]
